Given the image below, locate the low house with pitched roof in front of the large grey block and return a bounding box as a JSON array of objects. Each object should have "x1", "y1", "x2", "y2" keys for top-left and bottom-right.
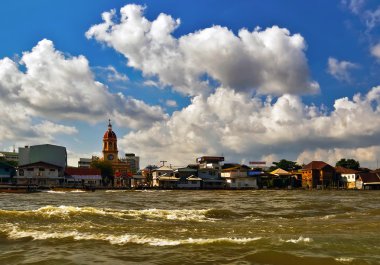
[{"x1": 16, "y1": 161, "x2": 64, "y2": 187}]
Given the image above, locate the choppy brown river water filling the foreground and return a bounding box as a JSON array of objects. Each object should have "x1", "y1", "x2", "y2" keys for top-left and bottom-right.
[{"x1": 0, "y1": 190, "x2": 380, "y2": 265}]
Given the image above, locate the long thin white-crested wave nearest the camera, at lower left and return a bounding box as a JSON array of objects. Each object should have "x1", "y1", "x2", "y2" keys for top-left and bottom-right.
[{"x1": 2, "y1": 225, "x2": 261, "y2": 247}]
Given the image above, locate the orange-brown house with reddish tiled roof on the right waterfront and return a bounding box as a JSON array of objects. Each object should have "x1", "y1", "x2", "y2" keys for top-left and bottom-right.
[{"x1": 302, "y1": 161, "x2": 336, "y2": 189}]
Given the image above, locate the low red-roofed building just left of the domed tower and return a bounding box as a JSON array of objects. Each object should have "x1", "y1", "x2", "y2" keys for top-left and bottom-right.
[{"x1": 65, "y1": 167, "x2": 102, "y2": 188}]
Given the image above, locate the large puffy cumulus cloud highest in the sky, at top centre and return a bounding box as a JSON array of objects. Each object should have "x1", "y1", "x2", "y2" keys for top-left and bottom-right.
[{"x1": 86, "y1": 4, "x2": 319, "y2": 95}]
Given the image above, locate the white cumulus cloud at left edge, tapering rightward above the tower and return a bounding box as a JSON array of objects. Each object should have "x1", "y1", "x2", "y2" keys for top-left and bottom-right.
[{"x1": 0, "y1": 39, "x2": 166, "y2": 129}]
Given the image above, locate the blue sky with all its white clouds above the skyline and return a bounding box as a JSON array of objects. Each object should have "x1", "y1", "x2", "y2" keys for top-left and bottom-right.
[{"x1": 0, "y1": 0, "x2": 380, "y2": 168}]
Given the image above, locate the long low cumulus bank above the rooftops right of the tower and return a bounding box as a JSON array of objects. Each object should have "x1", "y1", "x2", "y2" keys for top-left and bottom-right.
[{"x1": 119, "y1": 87, "x2": 380, "y2": 165}]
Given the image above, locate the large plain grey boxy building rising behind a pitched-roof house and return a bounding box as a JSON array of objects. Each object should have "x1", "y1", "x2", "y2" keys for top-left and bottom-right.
[{"x1": 18, "y1": 144, "x2": 67, "y2": 169}]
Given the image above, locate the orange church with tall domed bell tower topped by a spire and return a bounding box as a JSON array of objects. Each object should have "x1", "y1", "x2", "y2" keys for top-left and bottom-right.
[{"x1": 102, "y1": 120, "x2": 132, "y2": 187}]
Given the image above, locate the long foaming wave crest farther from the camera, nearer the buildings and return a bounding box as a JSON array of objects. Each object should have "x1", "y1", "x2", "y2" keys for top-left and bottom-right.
[{"x1": 0, "y1": 205, "x2": 221, "y2": 222}]
